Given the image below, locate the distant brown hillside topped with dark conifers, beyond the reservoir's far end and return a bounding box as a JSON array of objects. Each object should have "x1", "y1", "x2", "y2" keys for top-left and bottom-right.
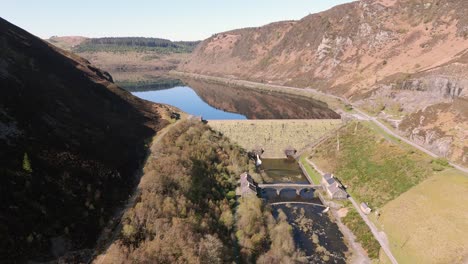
[{"x1": 47, "y1": 36, "x2": 200, "y2": 85}]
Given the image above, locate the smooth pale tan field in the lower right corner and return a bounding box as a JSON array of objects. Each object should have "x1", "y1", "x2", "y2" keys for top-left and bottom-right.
[{"x1": 378, "y1": 169, "x2": 468, "y2": 263}]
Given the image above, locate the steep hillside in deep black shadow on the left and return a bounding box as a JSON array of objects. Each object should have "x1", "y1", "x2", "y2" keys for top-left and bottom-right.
[{"x1": 0, "y1": 19, "x2": 165, "y2": 263}]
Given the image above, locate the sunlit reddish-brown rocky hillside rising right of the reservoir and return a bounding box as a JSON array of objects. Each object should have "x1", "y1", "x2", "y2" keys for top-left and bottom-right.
[{"x1": 179, "y1": 0, "x2": 468, "y2": 165}]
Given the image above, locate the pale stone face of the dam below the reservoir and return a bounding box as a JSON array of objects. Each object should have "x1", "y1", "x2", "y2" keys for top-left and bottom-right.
[{"x1": 208, "y1": 119, "x2": 341, "y2": 158}]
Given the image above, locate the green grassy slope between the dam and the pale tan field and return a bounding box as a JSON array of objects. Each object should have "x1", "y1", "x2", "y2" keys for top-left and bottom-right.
[{"x1": 312, "y1": 122, "x2": 432, "y2": 209}]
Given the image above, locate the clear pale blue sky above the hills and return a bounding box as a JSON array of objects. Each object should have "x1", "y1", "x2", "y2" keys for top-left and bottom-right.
[{"x1": 0, "y1": 0, "x2": 351, "y2": 40}]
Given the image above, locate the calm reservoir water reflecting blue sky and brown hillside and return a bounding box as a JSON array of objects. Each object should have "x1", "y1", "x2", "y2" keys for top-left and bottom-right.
[{"x1": 128, "y1": 79, "x2": 340, "y2": 120}]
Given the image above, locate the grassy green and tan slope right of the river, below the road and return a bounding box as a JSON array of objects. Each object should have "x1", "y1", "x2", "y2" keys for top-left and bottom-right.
[{"x1": 310, "y1": 122, "x2": 468, "y2": 263}]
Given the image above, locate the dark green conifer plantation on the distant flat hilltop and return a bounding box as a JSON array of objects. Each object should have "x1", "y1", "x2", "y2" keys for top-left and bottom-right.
[{"x1": 72, "y1": 37, "x2": 199, "y2": 54}]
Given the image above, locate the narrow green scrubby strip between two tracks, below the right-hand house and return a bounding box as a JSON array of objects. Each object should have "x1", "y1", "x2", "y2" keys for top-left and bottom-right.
[{"x1": 343, "y1": 207, "x2": 380, "y2": 259}]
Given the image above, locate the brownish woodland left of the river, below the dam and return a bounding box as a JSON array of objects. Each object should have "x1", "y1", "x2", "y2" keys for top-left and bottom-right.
[{"x1": 105, "y1": 121, "x2": 303, "y2": 263}]
